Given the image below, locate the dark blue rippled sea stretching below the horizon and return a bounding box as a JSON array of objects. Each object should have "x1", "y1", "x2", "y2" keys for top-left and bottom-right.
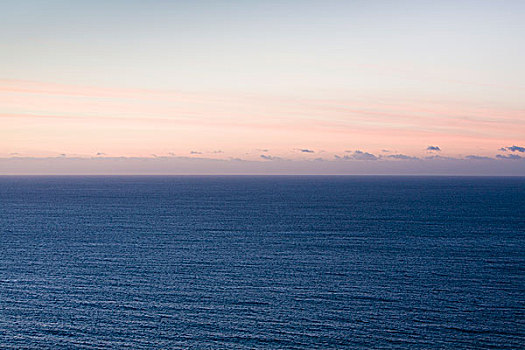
[{"x1": 0, "y1": 177, "x2": 525, "y2": 349}]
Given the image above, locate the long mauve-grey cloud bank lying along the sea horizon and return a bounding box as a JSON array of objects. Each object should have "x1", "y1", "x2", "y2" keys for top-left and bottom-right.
[{"x1": 0, "y1": 157, "x2": 525, "y2": 176}]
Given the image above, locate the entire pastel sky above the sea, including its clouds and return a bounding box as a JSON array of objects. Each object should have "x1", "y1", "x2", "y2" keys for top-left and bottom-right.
[{"x1": 0, "y1": 0, "x2": 525, "y2": 175}]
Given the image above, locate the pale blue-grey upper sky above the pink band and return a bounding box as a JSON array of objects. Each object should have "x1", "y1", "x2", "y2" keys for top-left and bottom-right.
[{"x1": 0, "y1": 0, "x2": 525, "y2": 100}]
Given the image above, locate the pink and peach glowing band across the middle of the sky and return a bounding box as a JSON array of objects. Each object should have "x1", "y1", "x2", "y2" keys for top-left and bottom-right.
[{"x1": 0, "y1": 80, "x2": 525, "y2": 159}]
